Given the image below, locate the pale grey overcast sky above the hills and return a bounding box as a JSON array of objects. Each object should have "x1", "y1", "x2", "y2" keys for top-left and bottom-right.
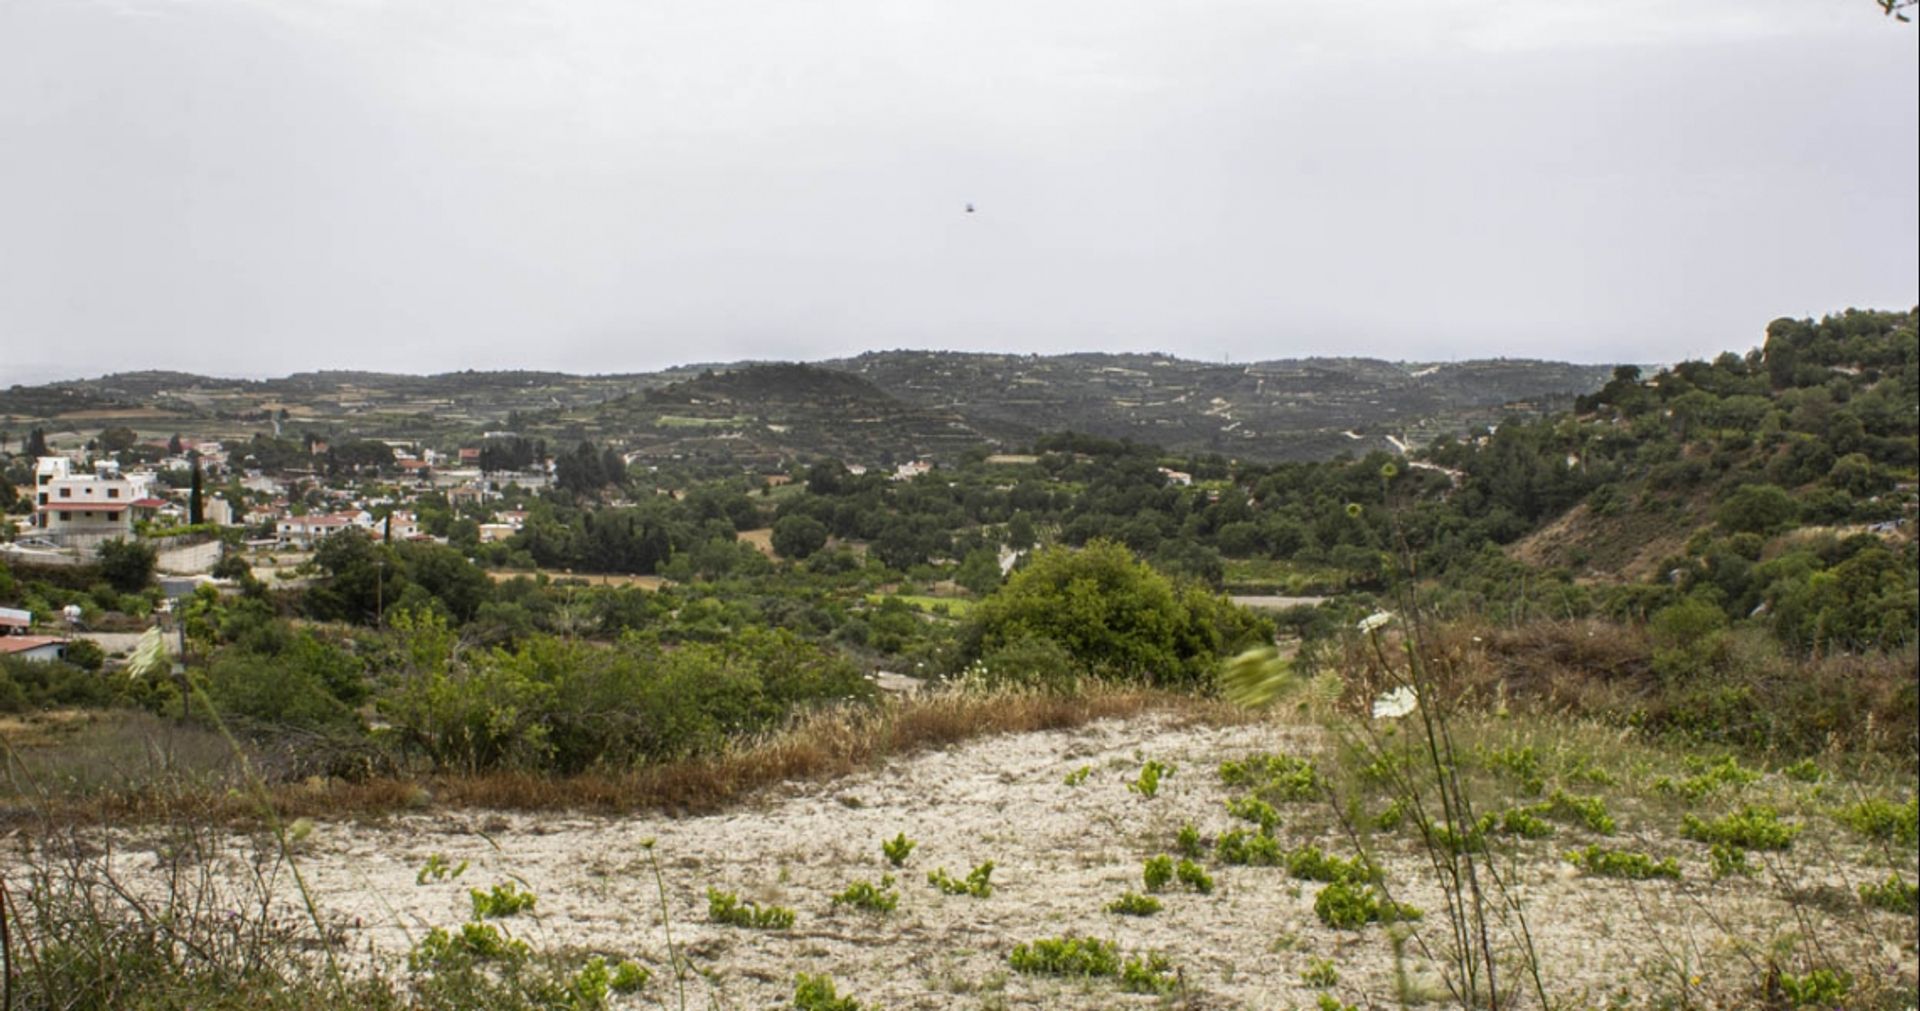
[{"x1": 0, "y1": 0, "x2": 1920, "y2": 384}]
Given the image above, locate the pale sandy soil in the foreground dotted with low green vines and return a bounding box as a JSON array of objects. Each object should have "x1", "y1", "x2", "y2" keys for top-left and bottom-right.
[{"x1": 63, "y1": 716, "x2": 1916, "y2": 1009}]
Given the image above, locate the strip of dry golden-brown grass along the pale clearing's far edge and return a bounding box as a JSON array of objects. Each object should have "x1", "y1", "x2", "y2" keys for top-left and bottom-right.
[{"x1": 15, "y1": 687, "x2": 1254, "y2": 823}]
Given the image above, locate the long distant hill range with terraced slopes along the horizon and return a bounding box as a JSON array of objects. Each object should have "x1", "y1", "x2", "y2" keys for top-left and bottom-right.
[{"x1": 0, "y1": 351, "x2": 1613, "y2": 464}]
